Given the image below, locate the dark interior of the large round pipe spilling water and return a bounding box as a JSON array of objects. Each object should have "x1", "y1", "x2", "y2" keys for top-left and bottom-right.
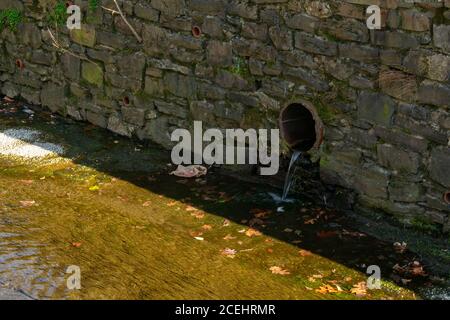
[{"x1": 280, "y1": 103, "x2": 317, "y2": 151}]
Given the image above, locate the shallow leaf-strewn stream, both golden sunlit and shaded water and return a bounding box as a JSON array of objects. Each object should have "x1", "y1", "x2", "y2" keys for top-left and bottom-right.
[{"x1": 0, "y1": 104, "x2": 444, "y2": 299}]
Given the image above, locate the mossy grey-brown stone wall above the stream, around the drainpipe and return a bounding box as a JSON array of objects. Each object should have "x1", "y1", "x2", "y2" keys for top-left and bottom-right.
[{"x1": 0, "y1": 0, "x2": 450, "y2": 231}]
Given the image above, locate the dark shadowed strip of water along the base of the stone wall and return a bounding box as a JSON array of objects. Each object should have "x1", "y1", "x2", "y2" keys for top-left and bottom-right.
[{"x1": 0, "y1": 100, "x2": 450, "y2": 300}]
